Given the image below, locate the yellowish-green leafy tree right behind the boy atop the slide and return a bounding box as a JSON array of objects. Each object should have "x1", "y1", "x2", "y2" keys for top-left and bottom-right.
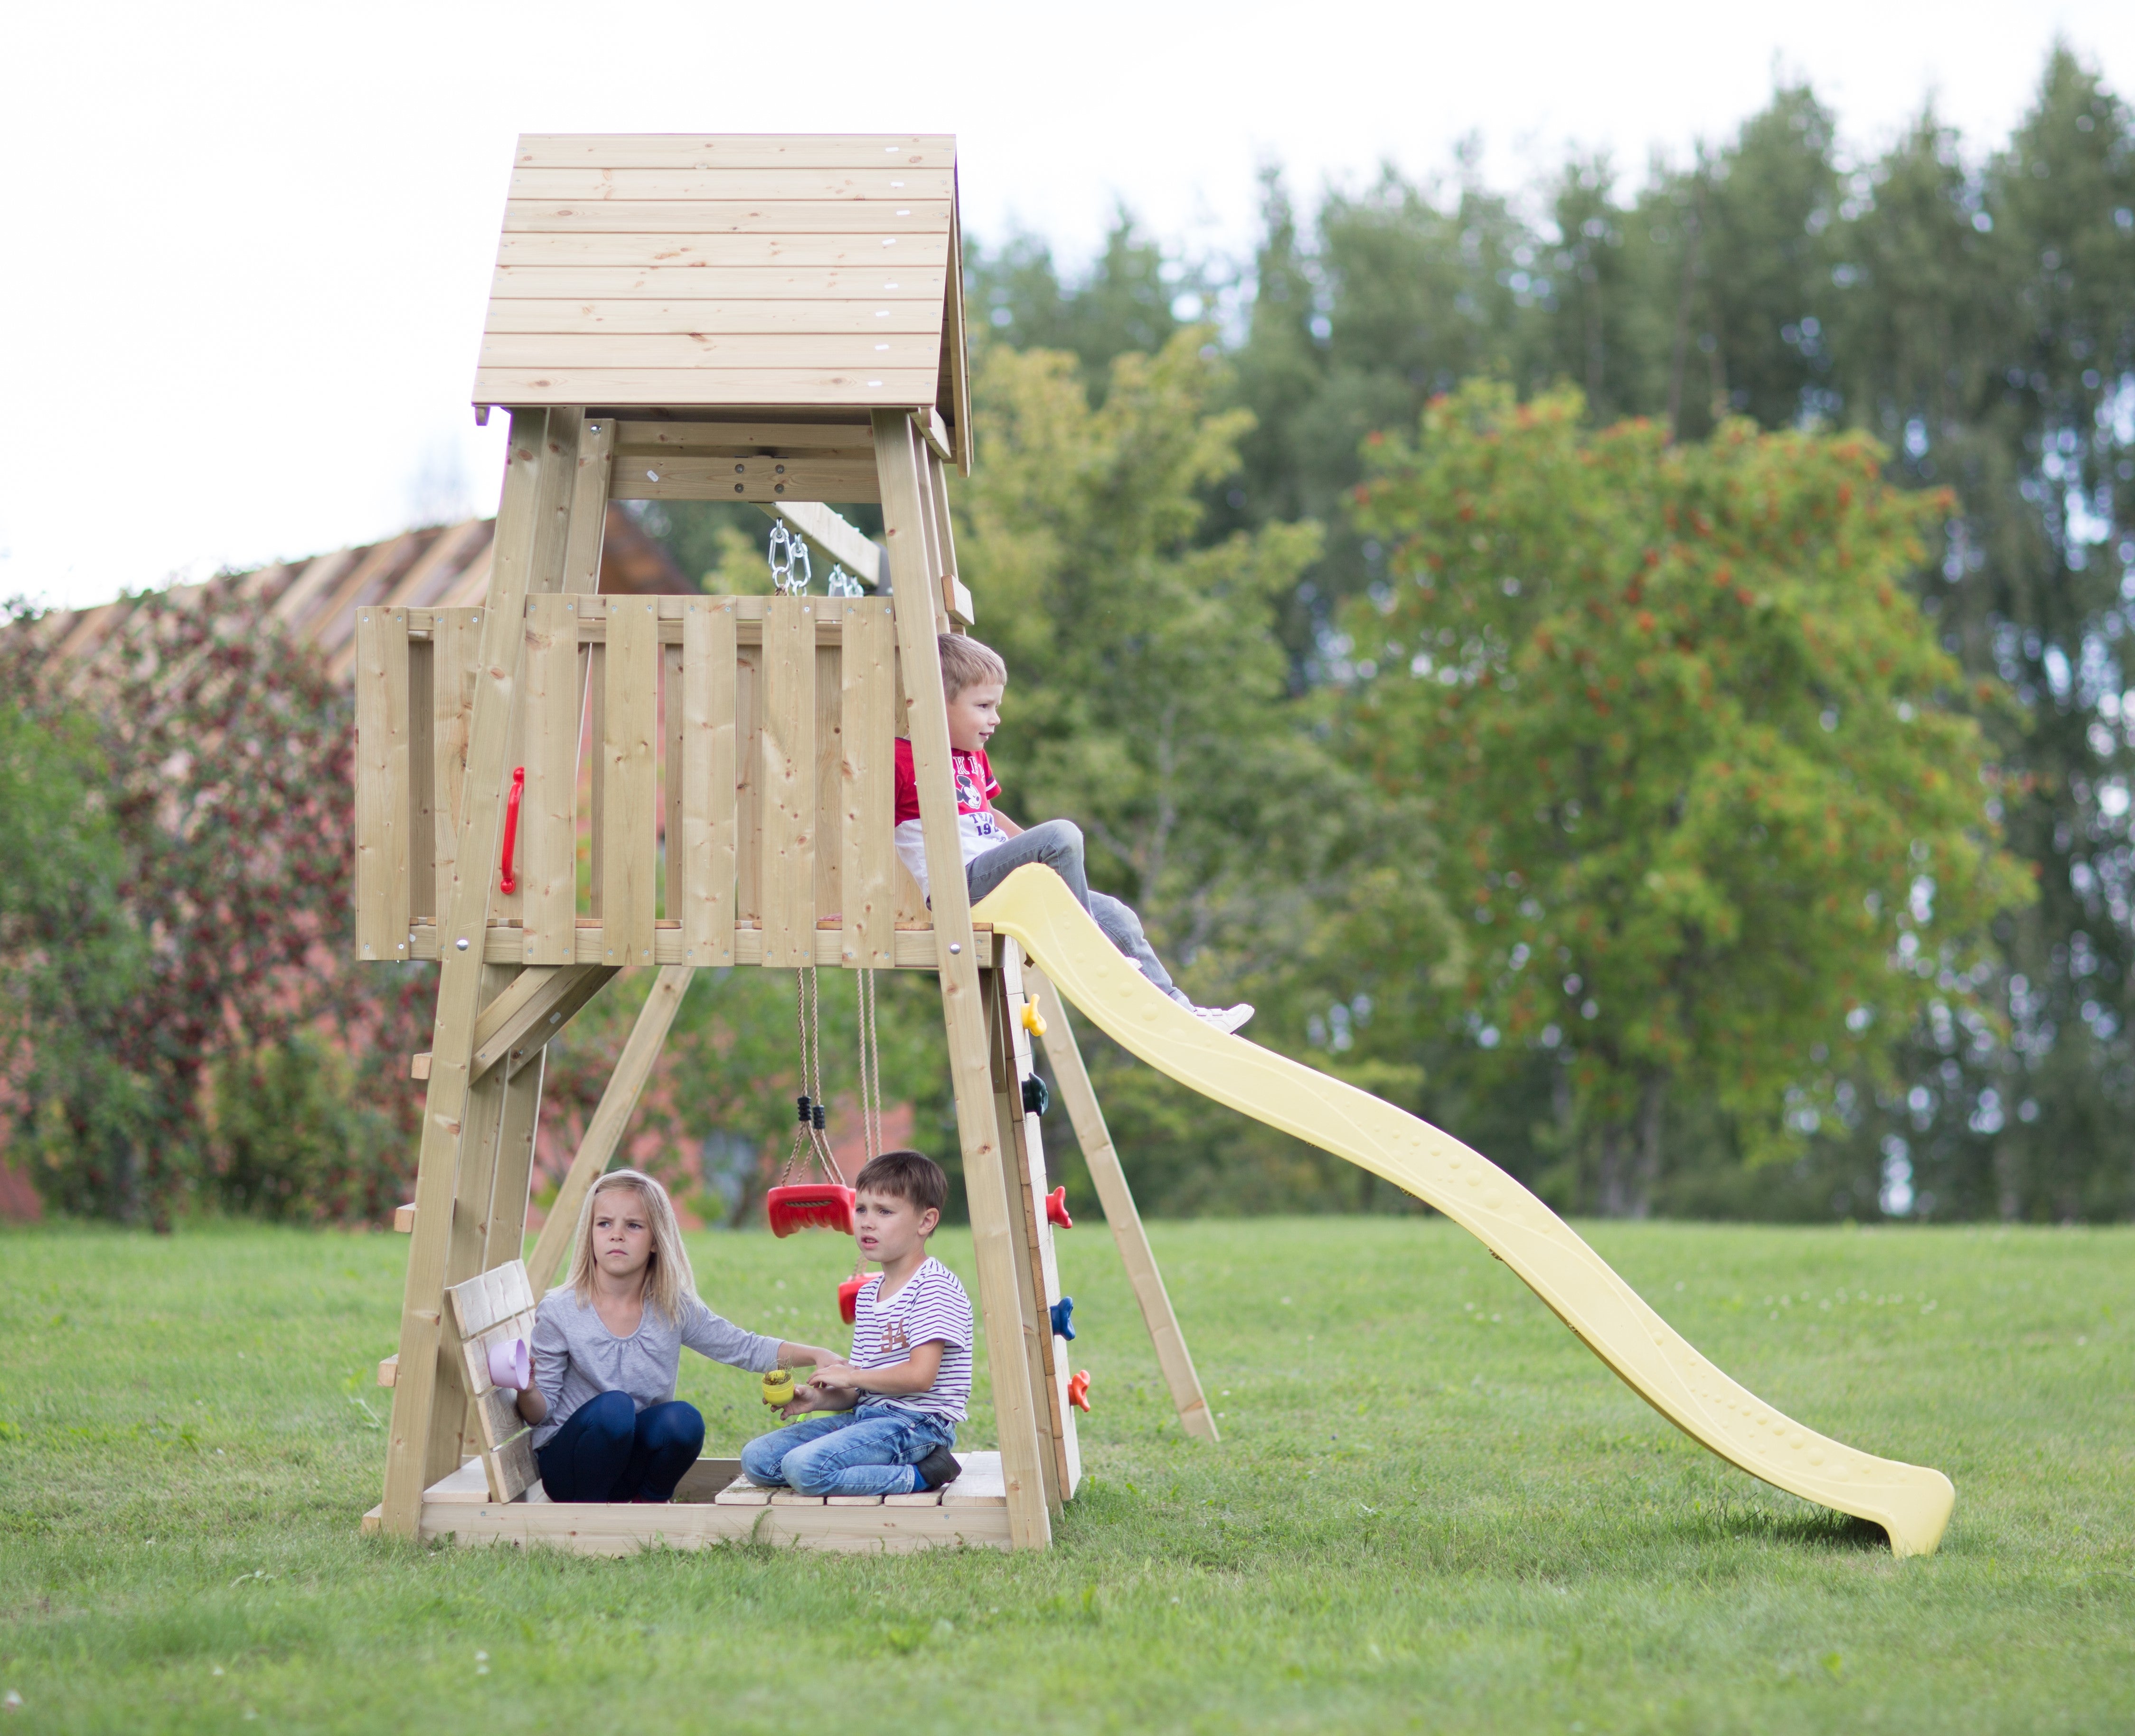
[{"x1": 957, "y1": 331, "x2": 1435, "y2": 1211}]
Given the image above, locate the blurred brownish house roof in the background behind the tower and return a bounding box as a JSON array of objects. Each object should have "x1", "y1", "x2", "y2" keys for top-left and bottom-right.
[{"x1": 34, "y1": 506, "x2": 696, "y2": 683}]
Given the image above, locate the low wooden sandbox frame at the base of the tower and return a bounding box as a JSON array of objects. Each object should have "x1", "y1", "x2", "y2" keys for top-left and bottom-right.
[{"x1": 363, "y1": 1452, "x2": 1010, "y2": 1555}]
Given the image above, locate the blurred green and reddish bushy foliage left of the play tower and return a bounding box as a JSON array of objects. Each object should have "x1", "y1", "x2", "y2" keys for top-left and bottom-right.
[{"x1": 0, "y1": 585, "x2": 412, "y2": 1228}]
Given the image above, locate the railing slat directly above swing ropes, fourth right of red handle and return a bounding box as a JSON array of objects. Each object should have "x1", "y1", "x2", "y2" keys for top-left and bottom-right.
[{"x1": 758, "y1": 596, "x2": 816, "y2": 970}]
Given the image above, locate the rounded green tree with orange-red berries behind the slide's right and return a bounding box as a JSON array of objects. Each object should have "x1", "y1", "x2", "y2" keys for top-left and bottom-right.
[{"x1": 1349, "y1": 384, "x2": 2031, "y2": 1215}]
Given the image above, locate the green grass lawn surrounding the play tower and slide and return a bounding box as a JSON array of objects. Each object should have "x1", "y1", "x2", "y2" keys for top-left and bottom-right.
[{"x1": 0, "y1": 1219, "x2": 2135, "y2": 1736}]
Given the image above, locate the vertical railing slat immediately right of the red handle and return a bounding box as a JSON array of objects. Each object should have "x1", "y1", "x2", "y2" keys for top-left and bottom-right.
[{"x1": 519, "y1": 592, "x2": 583, "y2": 965}]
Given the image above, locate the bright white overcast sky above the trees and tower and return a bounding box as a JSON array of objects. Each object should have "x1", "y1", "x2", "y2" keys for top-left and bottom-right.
[{"x1": 0, "y1": 0, "x2": 2135, "y2": 604}]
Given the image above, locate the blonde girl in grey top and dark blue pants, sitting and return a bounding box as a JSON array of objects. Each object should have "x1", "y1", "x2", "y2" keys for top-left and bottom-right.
[{"x1": 519, "y1": 1170, "x2": 837, "y2": 1501}]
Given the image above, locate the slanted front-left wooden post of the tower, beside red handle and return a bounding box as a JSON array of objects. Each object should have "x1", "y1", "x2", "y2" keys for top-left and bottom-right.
[{"x1": 380, "y1": 410, "x2": 583, "y2": 1538}]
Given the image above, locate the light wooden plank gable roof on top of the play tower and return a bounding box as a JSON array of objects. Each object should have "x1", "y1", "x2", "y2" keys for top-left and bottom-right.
[{"x1": 474, "y1": 132, "x2": 969, "y2": 470}]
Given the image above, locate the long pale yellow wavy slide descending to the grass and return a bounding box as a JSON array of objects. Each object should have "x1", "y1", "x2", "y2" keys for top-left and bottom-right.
[{"x1": 971, "y1": 865, "x2": 1956, "y2": 1557}]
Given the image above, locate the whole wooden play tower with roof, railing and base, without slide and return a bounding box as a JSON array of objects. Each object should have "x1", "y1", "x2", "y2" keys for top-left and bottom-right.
[{"x1": 357, "y1": 134, "x2": 1215, "y2": 1550}]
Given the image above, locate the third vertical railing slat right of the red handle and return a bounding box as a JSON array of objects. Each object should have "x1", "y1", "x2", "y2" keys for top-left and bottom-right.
[{"x1": 692, "y1": 598, "x2": 751, "y2": 965}]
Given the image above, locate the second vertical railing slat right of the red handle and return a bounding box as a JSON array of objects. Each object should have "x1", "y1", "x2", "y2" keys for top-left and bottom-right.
[{"x1": 600, "y1": 596, "x2": 660, "y2": 965}]
